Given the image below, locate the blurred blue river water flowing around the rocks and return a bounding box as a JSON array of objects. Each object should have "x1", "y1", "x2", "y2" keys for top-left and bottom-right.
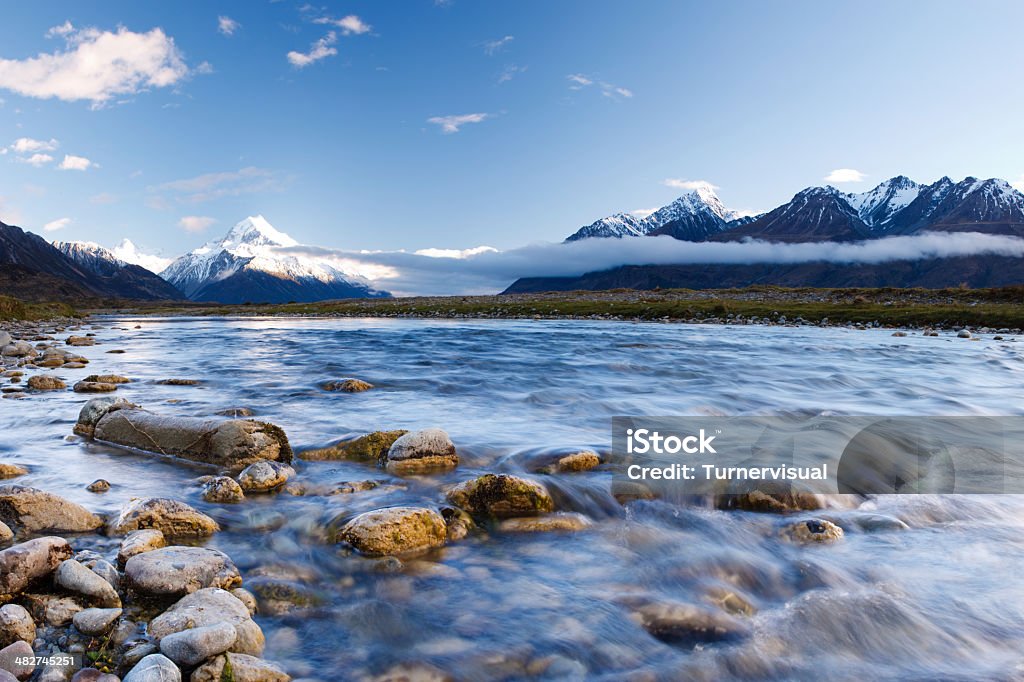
[{"x1": 0, "y1": 317, "x2": 1024, "y2": 680}]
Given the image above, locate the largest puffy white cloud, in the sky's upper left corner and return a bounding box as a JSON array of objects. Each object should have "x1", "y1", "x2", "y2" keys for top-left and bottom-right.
[{"x1": 0, "y1": 24, "x2": 188, "y2": 106}]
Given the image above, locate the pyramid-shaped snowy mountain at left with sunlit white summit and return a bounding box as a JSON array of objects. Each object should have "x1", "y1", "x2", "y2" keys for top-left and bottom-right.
[{"x1": 160, "y1": 215, "x2": 389, "y2": 303}]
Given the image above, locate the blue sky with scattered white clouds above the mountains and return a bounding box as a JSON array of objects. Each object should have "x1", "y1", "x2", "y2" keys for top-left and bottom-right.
[{"x1": 0, "y1": 0, "x2": 1024, "y2": 256}]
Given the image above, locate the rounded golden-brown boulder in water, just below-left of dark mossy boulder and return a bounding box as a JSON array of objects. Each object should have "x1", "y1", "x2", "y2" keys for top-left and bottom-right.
[{"x1": 338, "y1": 507, "x2": 447, "y2": 556}]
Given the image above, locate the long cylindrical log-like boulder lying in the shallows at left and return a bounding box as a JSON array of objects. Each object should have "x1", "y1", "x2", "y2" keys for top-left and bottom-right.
[{"x1": 93, "y1": 408, "x2": 292, "y2": 468}]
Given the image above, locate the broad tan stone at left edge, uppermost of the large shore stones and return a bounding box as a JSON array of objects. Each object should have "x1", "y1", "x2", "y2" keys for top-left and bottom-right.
[{"x1": 0, "y1": 485, "x2": 103, "y2": 532}]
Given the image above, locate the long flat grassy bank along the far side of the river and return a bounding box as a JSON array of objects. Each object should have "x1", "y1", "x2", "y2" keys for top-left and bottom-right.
[{"x1": 86, "y1": 287, "x2": 1024, "y2": 329}]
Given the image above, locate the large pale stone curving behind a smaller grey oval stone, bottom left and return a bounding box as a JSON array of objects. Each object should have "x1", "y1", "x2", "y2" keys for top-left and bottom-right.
[{"x1": 148, "y1": 588, "x2": 264, "y2": 656}]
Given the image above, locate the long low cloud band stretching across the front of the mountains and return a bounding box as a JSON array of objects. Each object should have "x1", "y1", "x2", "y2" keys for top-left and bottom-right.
[{"x1": 280, "y1": 232, "x2": 1024, "y2": 296}]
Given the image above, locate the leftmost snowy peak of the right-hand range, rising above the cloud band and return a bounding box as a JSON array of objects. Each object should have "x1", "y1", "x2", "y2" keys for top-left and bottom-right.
[{"x1": 565, "y1": 185, "x2": 745, "y2": 242}]
